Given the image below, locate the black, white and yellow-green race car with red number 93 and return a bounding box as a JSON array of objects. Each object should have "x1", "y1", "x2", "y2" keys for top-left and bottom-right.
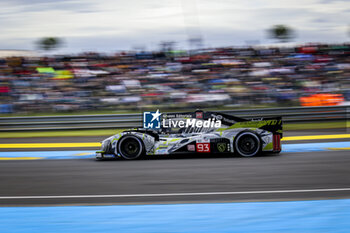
[{"x1": 96, "y1": 110, "x2": 283, "y2": 160}]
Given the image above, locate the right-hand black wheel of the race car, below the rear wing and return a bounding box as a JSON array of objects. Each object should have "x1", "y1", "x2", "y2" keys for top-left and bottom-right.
[{"x1": 234, "y1": 131, "x2": 261, "y2": 157}]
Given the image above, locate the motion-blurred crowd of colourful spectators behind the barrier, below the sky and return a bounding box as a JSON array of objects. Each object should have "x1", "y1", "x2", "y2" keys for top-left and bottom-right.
[{"x1": 0, "y1": 44, "x2": 350, "y2": 113}]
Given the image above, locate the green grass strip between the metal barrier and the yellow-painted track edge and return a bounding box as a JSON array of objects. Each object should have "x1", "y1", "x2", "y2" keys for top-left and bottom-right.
[{"x1": 0, "y1": 121, "x2": 350, "y2": 138}]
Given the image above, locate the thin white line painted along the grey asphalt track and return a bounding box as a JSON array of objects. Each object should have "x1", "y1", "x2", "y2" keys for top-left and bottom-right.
[{"x1": 0, "y1": 188, "x2": 350, "y2": 199}]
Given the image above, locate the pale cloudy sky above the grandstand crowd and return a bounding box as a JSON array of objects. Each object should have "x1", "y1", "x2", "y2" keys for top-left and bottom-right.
[{"x1": 0, "y1": 0, "x2": 350, "y2": 53}]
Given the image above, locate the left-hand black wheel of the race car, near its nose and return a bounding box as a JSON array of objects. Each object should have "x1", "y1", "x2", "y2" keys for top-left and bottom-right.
[{"x1": 117, "y1": 135, "x2": 144, "y2": 159}]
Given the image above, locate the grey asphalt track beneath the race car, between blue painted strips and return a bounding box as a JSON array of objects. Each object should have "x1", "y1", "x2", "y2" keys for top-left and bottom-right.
[{"x1": 0, "y1": 130, "x2": 350, "y2": 206}]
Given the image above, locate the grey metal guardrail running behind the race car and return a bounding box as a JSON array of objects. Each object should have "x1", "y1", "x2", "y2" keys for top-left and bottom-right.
[{"x1": 0, "y1": 106, "x2": 350, "y2": 132}]
